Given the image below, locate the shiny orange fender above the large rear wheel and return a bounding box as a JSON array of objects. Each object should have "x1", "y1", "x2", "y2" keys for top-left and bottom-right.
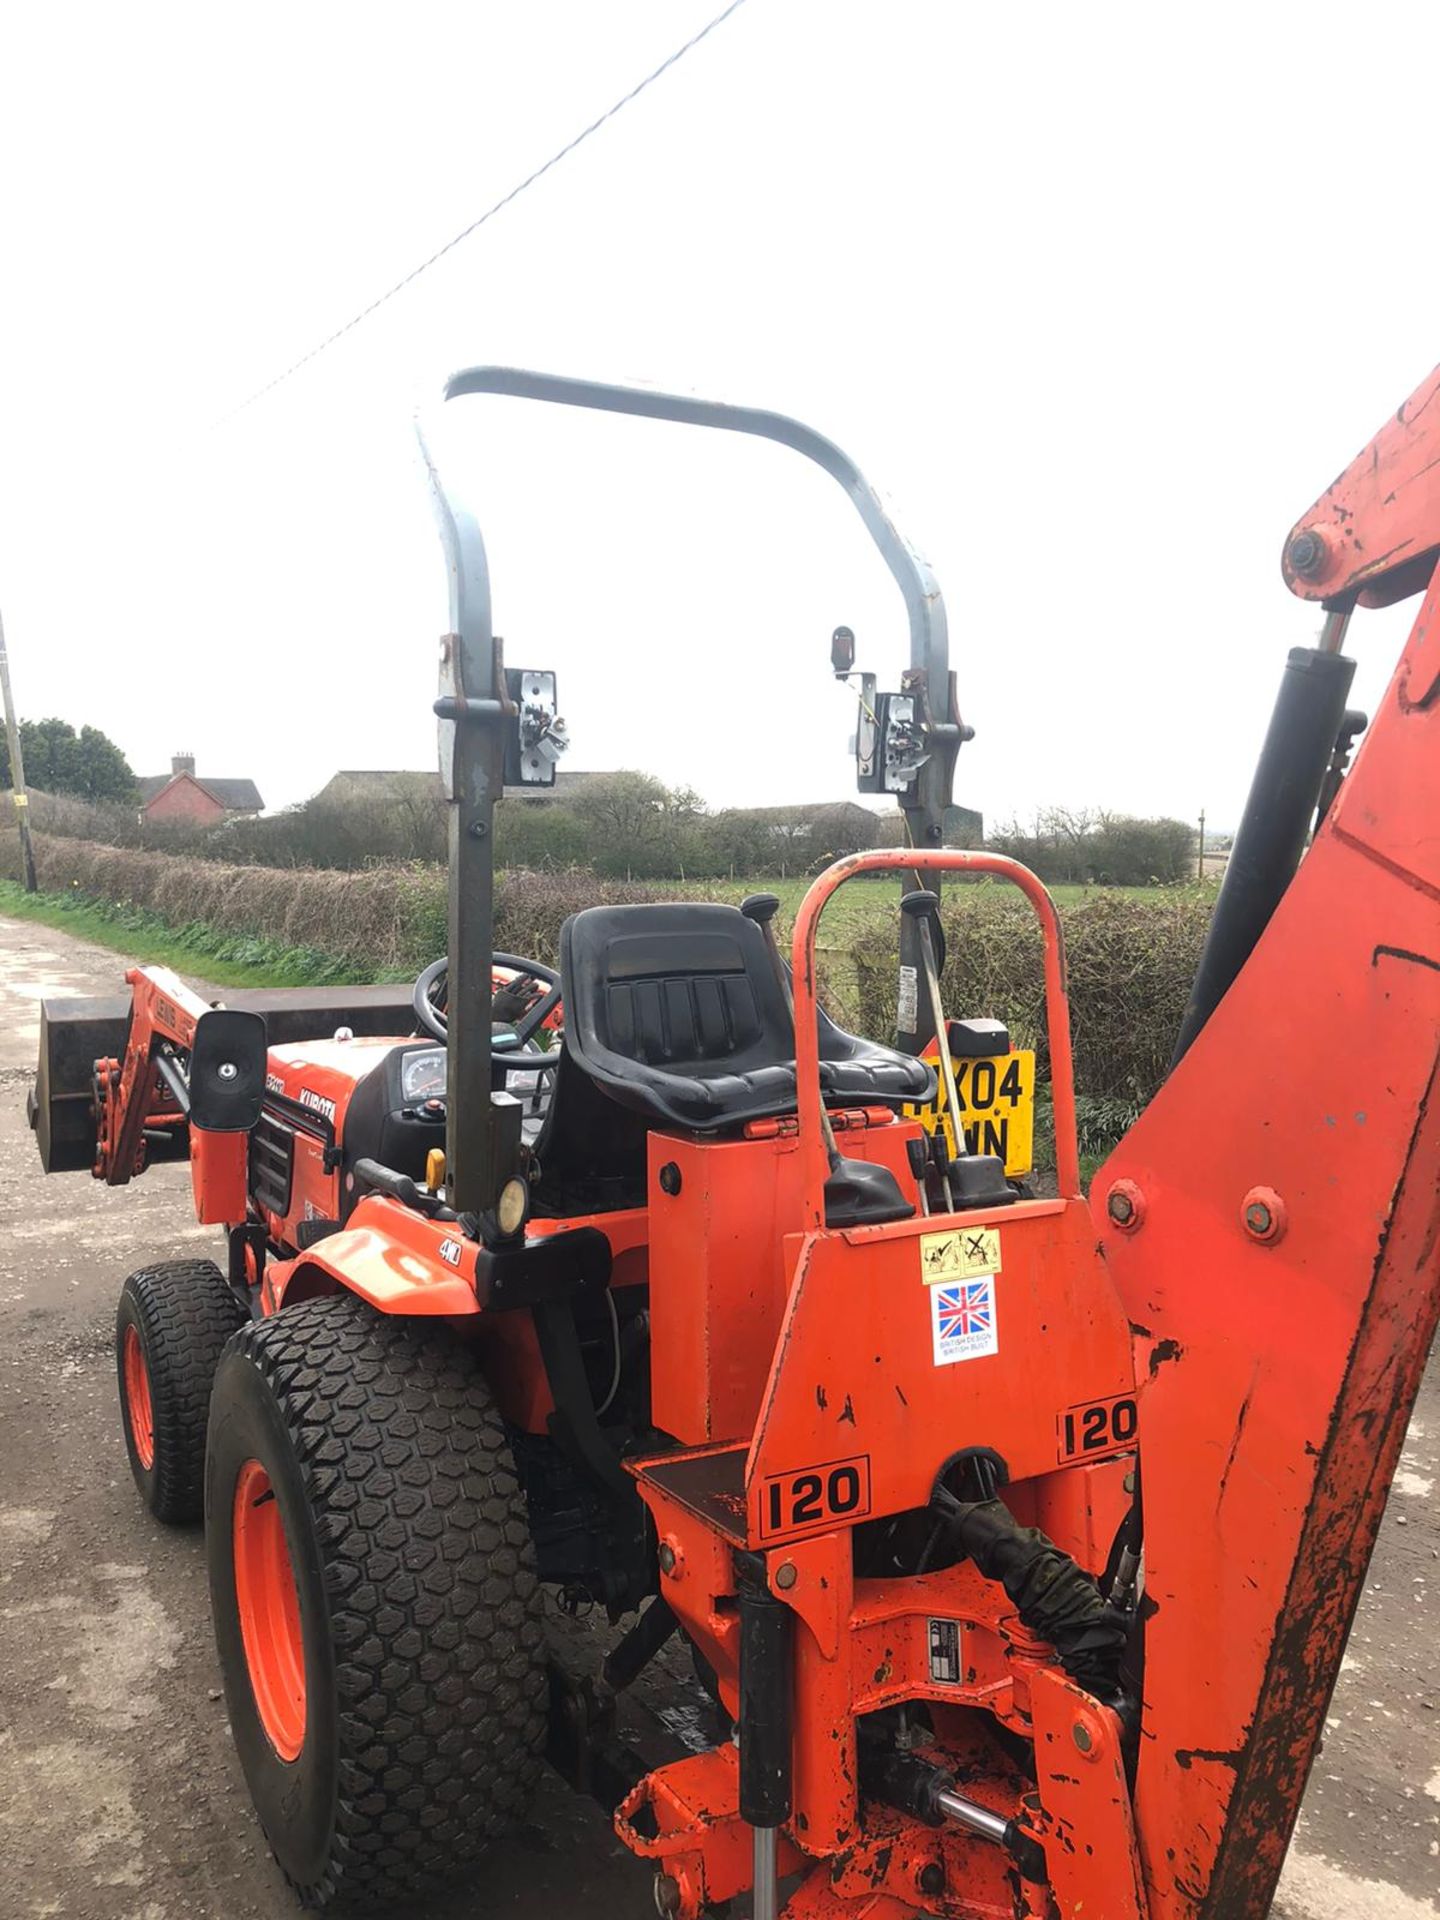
[{"x1": 267, "y1": 1194, "x2": 480, "y2": 1317}]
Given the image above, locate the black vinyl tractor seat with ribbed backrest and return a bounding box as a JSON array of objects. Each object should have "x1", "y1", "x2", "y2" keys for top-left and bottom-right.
[{"x1": 557, "y1": 902, "x2": 935, "y2": 1133}]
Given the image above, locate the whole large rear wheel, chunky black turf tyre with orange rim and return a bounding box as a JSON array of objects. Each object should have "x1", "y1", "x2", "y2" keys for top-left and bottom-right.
[{"x1": 205, "y1": 1298, "x2": 547, "y2": 1910}]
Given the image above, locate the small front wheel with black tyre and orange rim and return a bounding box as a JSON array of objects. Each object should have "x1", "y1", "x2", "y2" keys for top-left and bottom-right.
[{"x1": 115, "y1": 1260, "x2": 248, "y2": 1524}]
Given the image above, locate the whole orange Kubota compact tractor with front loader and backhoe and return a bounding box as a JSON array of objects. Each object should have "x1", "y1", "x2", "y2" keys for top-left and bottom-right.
[{"x1": 33, "y1": 367, "x2": 1440, "y2": 1920}]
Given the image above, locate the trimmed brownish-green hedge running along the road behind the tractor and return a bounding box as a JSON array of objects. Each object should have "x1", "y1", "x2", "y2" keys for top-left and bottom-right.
[{"x1": 0, "y1": 833, "x2": 1213, "y2": 1133}]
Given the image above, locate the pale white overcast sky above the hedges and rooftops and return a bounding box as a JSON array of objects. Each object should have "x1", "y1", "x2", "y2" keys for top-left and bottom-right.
[{"x1": 0, "y1": 0, "x2": 1440, "y2": 824}]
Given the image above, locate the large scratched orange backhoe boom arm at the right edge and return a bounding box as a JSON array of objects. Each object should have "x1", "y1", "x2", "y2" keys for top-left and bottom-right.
[{"x1": 1091, "y1": 374, "x2": 1440, "y2": 1920}]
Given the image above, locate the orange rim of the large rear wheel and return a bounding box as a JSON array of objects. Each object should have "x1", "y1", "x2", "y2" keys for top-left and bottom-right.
[{"x1": 232, "y1": 1459, "x2": 305, "y2": 1761}]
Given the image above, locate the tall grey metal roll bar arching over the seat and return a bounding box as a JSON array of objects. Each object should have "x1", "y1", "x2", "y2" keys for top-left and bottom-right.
[{"x1": 417, "y1": 367, "x2": 960, "y2": 1210}]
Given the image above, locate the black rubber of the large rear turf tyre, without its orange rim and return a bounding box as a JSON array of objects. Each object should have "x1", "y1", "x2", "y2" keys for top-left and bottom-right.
[{"x1": 207, "y1": 1296, "x2": 547, "y2": 1910}]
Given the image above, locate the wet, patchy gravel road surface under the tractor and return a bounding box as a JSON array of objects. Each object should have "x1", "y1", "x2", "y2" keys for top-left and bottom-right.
[{"x1": 0, "y1": 920, "x2": 1440, "y2": 1920}]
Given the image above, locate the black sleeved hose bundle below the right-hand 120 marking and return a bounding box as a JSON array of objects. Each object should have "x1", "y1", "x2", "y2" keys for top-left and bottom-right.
[{"x1": 935, "y1": 1488, "x2": 1129, "y2": 1701}]
